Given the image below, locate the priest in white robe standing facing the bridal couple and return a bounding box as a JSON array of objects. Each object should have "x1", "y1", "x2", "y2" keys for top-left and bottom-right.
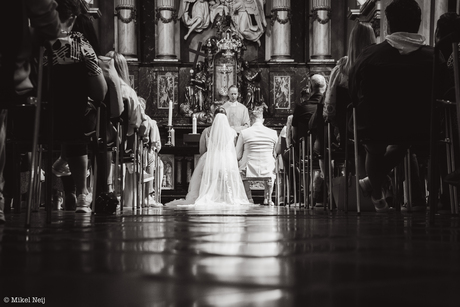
[{"x1": 222, "y1": 85, "x2": 249, "y2": 133}]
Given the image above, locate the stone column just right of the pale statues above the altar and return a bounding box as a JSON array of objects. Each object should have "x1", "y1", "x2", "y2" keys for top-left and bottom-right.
[{"x1": 270, "y1": 0, "x2": 294, "y2": 62}]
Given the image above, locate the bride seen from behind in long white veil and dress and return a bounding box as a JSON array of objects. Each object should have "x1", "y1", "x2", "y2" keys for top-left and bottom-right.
[{"x1": 166, "y1": 108, "x2": 250, "y2": 207}]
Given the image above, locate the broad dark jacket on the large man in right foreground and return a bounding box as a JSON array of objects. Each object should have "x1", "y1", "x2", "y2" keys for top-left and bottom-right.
[{"x1": 349, "y1": 41, "x2": 434, "y2": 140}]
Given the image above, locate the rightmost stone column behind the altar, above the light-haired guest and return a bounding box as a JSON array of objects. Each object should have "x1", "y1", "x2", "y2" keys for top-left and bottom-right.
[{"x1": 309, "y1": 0, "x2": 335, "y2": 75}]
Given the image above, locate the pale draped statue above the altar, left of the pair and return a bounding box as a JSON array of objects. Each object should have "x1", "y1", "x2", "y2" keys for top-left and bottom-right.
[{"x1": 178, "y1": 0, "x2": 210, "y2": 40}]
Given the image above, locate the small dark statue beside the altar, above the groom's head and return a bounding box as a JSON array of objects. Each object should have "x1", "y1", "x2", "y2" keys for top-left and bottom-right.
[{"x1": 241, "y1": 61, "x2": 263, "y2": 110}]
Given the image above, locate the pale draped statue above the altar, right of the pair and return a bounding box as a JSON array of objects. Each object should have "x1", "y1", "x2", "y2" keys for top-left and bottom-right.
[{"x1": 232, "y1": 0, "x2": 267, "y2": 46}]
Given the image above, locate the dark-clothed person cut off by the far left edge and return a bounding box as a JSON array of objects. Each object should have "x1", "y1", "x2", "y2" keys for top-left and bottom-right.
[{"x1": 0, "y1": 0, "x2": 61, "y2": 224}]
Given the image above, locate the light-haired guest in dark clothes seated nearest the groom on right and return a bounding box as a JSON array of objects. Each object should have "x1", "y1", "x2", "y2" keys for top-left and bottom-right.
[{"x1": 292, "y1": 74, "x2": 326, "y2": 206}]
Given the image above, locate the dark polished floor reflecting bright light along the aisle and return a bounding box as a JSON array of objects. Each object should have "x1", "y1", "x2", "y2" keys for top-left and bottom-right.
[{"x1": 0, "y1": 206, "x2": 460, "y2": 307}]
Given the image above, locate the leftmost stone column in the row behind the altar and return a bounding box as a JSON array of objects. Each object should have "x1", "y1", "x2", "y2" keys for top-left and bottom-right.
[{"x1": 115, "y1": 0, "x2": 137, "y2": 58}]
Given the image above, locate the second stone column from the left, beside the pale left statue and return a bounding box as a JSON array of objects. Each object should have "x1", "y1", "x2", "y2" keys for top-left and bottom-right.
[{"x1": 155, "y1": 0, "x2": 177, "y2": 61}]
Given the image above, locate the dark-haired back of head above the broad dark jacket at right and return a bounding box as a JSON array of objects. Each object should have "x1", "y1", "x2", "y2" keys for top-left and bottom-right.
[{"x1": 385, "y1": 0, "x2": 422, "y2": 34}]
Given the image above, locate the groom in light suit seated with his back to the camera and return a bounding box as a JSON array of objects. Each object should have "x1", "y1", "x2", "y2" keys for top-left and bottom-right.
[{"x1": 236, "y1": 107, "x2": 278, "y2": 205}]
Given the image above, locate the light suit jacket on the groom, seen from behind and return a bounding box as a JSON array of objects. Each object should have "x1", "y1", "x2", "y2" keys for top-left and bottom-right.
[{"x1": 236, "y1": 122, "x2": 278, "y2": 177}]
